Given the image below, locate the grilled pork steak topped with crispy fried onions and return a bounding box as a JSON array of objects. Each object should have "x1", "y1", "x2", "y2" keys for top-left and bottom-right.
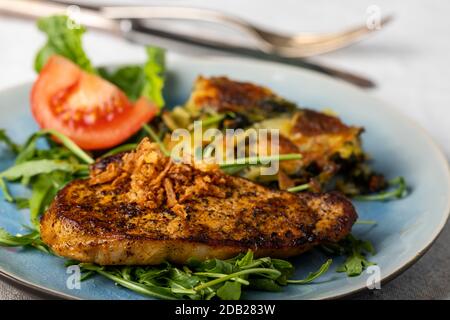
[{"x1": 41, "y1": 139, "x2": 357, "y2": 265}]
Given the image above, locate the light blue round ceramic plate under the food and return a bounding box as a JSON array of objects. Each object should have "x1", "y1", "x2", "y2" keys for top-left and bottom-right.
[{"x1": 0, "y1": 56, "x2": 450, "y2": 299}]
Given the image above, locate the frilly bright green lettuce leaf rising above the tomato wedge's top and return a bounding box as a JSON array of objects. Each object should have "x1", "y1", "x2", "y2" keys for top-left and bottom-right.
[{"x1": 34, "y1": 15, "x2": 95, "y2": 73}]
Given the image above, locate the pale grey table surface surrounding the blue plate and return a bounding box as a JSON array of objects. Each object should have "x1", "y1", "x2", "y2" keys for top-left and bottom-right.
[{"x1": 0, "y1": 0, "x2": 450, "y2": 299}]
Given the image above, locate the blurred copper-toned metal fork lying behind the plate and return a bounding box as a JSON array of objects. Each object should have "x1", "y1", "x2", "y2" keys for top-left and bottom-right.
[{"x1": 100, "y1": 6, "x2": 392, "y2": 58}]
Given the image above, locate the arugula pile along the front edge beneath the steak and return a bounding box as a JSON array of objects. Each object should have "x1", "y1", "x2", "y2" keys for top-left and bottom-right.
[{"x1": 74, "y1": 250, "x2": 331, "y2": 300}]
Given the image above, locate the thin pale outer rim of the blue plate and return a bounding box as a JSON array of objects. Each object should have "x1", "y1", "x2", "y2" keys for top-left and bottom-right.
[{"x1": 0, "y1": 53, "x2": 450, "y2": 300}]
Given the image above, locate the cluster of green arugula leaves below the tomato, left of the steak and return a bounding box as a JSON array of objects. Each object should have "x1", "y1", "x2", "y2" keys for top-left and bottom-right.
[{"x1": 0, "y1": 130, "x2": 93, "y2": 230}]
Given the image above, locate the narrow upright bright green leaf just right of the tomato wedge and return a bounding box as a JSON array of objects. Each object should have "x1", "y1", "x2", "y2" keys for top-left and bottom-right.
[{"x1": 141, "y1": 47, "x2": 165, "y2": 108}]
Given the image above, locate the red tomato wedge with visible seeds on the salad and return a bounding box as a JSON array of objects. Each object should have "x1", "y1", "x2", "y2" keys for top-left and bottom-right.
[{"x1": 31, "y1": 55, "x2": 158, "y2": 150}]
